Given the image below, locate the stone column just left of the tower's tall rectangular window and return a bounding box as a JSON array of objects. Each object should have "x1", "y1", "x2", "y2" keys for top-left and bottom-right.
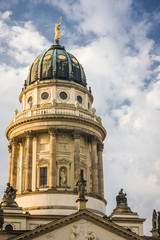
[{"x1": 24, "y1": 131, "x2": 33, "y2": 192}]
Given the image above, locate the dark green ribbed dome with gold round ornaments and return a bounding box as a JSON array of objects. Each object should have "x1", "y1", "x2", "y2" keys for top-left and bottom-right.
[{"x1": 27, "y1": 44, "x2": 87, "y2": 86}]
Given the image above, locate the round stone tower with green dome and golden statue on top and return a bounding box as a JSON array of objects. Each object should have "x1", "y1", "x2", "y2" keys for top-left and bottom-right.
[{"x1": 6, "y1": 19, "x2": 106, "y2": 216}]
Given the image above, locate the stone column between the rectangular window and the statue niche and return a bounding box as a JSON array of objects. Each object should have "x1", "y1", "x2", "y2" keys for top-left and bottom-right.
[{"x1": 49, "y1": 129, "x2": 57, "y2": 189}]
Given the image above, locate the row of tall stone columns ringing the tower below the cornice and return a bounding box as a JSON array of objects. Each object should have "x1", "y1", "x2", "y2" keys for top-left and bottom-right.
[{"x1": 8, "y1": 129, "x2": 104, "y2": 197}]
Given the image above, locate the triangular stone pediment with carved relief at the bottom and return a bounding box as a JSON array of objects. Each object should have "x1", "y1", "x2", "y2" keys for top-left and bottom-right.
[{"x1": 10, "y1": 210, "x2": 143, "y2": 240}]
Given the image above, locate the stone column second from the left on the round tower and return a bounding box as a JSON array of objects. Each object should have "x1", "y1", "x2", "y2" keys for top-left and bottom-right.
[{"x1": 10, "y1": 137, "x2": 18, "y2": 189}]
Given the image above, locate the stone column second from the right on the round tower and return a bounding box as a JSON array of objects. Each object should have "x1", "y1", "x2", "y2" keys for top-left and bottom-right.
[{"x1": 91, "y1": 137, "x2": 98, "y2": 194}]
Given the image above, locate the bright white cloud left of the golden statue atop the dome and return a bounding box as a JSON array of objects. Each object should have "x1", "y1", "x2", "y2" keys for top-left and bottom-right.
[{"x1": 0, "y1": 11, "x2": 50, "y2": 64}]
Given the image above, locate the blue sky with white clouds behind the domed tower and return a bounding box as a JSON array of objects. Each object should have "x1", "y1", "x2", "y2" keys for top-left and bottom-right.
[{"x1": 0, "y1": 0, "x2": 160, "y2": 235}]
